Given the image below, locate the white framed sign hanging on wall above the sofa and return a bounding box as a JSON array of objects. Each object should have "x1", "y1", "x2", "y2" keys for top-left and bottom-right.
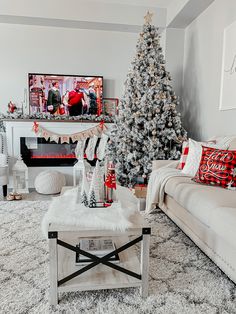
[{"x1": 219, "y1": 21, "x2": 236, "y2": 110}]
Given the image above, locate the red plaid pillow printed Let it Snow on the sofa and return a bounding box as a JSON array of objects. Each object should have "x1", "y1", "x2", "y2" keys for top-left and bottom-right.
[{"x1": 193, "y1": 146, "x2": 236, "y2": 189}]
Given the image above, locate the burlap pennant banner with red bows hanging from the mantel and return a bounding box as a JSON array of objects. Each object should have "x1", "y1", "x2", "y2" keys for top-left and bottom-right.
[{"x1": 32, "y1": 121, "x2": 107, "y2": 144}]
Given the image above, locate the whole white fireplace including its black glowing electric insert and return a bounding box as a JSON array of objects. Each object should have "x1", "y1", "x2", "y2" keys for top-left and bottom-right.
[{"x1": 5, "y1": 119, "x2": 113, "y2": 188}]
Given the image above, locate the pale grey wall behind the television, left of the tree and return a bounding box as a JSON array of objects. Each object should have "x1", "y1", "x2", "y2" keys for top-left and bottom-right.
[{"x1": 0, "y1": 24, "x2": 138, "y2": 111}]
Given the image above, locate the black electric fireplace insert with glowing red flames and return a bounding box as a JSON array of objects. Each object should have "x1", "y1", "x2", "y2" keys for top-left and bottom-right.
[{"x1": 20, "y1": 137, "x2": 77, "y2": 167}]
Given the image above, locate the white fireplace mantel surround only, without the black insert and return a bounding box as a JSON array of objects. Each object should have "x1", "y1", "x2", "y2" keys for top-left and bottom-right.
[{"x1": 4, "y1": 120, "x2": 112, "y2": 188}]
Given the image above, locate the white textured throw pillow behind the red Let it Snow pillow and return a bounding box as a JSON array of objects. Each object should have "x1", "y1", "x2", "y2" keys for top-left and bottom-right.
[{"x1": 182, "y1": 138, "x2": 228, "y2": 177}]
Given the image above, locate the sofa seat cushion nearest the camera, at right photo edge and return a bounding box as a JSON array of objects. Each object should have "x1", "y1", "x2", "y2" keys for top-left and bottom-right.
[{"x1": 210, "y1": 207, "x2": 236, "y2": 247}]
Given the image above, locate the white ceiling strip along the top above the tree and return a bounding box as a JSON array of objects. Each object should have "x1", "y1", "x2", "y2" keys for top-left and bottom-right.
[{"x1": 0, "y1": 0, "x2": 216, "y2": 33}]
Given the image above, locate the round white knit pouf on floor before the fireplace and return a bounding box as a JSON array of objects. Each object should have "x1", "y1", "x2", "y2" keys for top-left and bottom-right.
[{"x1": 34, "y1": 170, "x2": 66, "y2": 194}]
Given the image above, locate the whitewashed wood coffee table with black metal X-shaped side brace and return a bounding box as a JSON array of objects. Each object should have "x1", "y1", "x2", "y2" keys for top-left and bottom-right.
[{"x1": 48, "y1": 209, "x2": 151, "y2": 305}]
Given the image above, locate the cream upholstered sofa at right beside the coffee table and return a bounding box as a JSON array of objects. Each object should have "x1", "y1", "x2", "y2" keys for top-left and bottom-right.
[{"x1": 152, "y1": 138, "x2": 236, "y2": 283}]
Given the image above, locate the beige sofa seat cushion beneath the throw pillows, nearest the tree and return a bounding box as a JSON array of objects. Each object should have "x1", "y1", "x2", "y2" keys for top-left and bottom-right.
[{"x1": 165, "y1": 177, "x2": 236, "y2": 227}]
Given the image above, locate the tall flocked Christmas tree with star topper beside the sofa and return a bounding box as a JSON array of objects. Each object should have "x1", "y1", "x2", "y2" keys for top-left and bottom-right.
[{"x1": 108, "y1": 12, "x2": 186, "y2": 186}]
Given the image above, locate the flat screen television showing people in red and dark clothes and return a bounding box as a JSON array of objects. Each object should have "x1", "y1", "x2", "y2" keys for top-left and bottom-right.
[{"x1": 28, "y1": 73, "x2": 103, "y2": 116}]
